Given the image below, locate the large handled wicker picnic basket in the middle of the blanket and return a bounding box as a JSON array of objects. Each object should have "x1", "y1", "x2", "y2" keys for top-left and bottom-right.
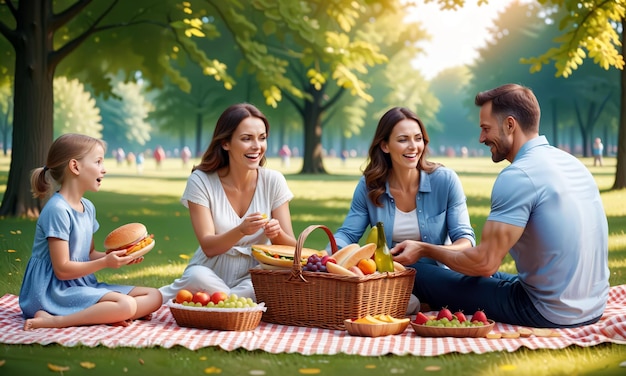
[{"x1": 250, "y1": 225, "x2": 415, "y2": 330}]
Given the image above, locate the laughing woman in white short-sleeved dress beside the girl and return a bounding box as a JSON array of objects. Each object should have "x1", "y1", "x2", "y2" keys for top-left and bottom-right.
[{"x1": 160, "y1": 103, "x2": 296, "y2": 303}]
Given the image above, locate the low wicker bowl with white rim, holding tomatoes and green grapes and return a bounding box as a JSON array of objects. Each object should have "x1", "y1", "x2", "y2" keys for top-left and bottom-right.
[{"x1": 167, "y1": 300, "x2": 266, "y2": 332}]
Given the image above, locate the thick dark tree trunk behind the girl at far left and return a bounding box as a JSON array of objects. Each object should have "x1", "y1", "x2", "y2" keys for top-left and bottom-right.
[{"x1": 0, "y1": 0, "x2": 54, "y2": 217}]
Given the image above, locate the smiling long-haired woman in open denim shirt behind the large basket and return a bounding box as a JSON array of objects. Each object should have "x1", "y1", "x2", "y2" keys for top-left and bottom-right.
[{"x1": 335, "y1": 107, "x2": 476, "y2": 314}]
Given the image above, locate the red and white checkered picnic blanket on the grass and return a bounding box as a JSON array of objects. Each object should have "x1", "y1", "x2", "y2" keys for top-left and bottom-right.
[{"x1": 0, "y1": 285, "x2": 626, "y2": 356}]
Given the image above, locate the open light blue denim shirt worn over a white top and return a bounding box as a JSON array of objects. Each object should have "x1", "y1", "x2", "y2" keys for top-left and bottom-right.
[{"x1": 327, "y1": 166, "x2": 476, "y2": 250}]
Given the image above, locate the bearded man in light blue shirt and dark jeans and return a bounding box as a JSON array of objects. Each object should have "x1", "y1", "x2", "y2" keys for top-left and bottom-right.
[{"x1": 391, "y1": 84, "x2": 609, "y2": 328}]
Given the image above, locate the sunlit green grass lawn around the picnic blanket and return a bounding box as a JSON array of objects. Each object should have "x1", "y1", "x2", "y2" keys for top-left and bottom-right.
[{"x1": 0, "y1": 157, "x2": 626, "y2": 375}]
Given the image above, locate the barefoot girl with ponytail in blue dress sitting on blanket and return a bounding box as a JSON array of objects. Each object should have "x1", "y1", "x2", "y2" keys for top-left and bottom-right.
[{"x1": 19, "y1": 134, "x2": 161, "y2": 330}]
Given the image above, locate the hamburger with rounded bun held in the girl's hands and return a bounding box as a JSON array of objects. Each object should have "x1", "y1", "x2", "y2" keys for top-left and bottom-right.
[{"x1": 104, "y1": 222, "x2": 154, "y2": 256}]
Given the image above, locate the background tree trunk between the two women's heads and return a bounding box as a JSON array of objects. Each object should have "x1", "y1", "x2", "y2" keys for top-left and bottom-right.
[{"x1": 300, "y1": 88, "x2": 326, "y2": 174}]
